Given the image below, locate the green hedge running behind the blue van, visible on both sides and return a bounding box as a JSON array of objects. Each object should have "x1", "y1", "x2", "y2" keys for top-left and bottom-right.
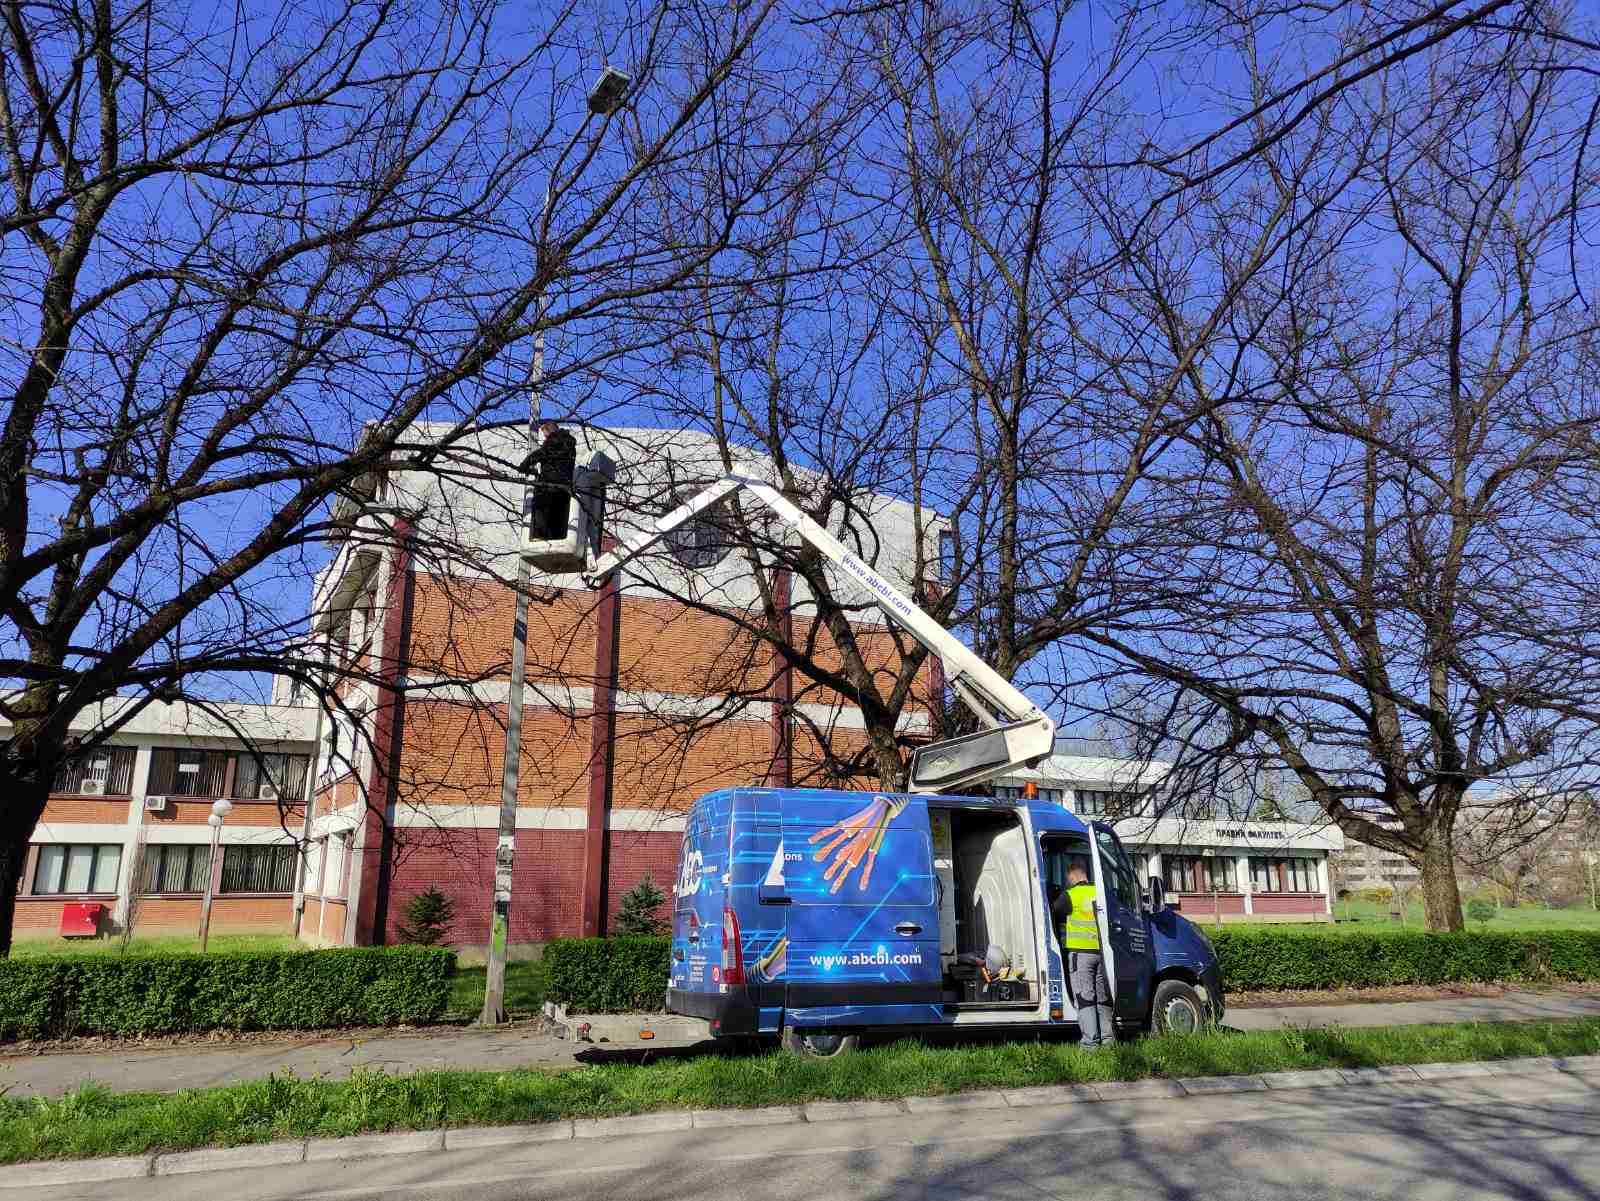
[{"x1": 544, "y1": 926, "x2": 1600, "y2": 1014}]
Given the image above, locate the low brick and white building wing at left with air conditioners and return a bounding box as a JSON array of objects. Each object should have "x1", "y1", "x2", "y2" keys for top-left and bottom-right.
[{"x1": 0, "y1": 700, "x2": 315, "y2": 939}]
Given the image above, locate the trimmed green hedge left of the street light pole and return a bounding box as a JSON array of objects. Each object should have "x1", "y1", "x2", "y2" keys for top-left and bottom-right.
[{"x1": 0, "y1": 947, "x2": 456, "y2": 1038}]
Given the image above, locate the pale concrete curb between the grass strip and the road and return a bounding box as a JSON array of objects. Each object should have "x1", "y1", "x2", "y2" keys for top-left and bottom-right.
[{"x1": 0, "y1": 1055, "x2": 1600, "y2": 1193}]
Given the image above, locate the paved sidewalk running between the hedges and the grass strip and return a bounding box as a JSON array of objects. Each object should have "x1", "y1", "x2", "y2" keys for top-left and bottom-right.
[{"x1": 0, "y1": 993, "x2": 1600, "y2": 1097}]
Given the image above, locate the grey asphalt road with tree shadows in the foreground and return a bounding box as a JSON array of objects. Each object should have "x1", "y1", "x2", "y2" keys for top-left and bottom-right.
[{"x1": 29, "y1": 1071, "x2": 1600, "y2": 1201}]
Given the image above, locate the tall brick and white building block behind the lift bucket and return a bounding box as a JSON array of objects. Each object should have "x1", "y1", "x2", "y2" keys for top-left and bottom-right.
[{"x1": 294, "y1": 430, "x2": 938, "y2": 952}]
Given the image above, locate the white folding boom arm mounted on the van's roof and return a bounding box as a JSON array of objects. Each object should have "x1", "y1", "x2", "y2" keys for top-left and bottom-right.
[{"x1": 582, "y1": 475, "x2": 1056, "y2": 793}]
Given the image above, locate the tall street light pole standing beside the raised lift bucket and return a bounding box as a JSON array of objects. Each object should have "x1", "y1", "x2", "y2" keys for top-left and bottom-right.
[{"x1": 478, "y1": 67, "x2": 632, "y2": 1025}]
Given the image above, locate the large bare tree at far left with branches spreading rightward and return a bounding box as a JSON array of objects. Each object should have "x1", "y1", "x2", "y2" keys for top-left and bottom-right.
[{"x1": 0, "y1": 0, "x2": 800, "y2": 953}]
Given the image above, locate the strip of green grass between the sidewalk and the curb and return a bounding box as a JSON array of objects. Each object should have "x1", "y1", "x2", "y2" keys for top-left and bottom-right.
[{"x1": 0, "y1": 1019, "x2": 1600, "y2": 1163}]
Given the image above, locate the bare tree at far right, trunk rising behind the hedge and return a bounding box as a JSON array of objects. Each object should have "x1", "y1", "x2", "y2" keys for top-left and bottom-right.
[{"x1": 1102, "y1": 32, "x2": 1600, "y2": 929}]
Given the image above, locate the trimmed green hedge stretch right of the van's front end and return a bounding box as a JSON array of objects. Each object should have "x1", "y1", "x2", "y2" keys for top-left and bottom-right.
[{"x1": 1208, "y1": 926, "x2": 1600, "y2": 992}]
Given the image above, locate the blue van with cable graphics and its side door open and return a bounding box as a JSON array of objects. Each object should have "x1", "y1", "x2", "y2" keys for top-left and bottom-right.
[{"x1": 667, "y1": 788, "x2": 1222, "y2": 1057}]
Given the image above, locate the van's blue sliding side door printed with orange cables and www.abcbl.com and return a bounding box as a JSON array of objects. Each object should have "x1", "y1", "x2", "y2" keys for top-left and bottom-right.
[{"x1": 780, "y1": 792, "x2": 944, "y2": 1027}]
